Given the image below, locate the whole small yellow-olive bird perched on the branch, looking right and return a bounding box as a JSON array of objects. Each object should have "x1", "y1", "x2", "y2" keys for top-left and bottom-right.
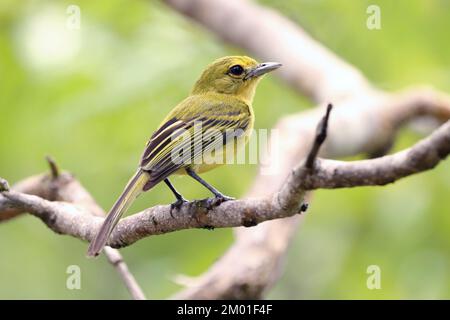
[{"x1": 87, "y1": 56, "x2": 281, "y2": 257}]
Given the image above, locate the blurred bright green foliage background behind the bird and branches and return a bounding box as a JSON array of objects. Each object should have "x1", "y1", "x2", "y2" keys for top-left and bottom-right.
[{"x1": 0, "y1": 0, "x2": 450, "y2": 299}]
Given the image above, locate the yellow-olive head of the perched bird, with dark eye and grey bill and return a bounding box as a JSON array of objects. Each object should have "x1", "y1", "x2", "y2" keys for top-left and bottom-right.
[{"x1": 192, "y1": 56, "x2": 281, "y2": 103}]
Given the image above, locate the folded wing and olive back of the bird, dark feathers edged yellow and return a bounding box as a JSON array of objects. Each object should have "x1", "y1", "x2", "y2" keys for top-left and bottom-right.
[{"x1": 140, "y1": 99, "x2": 250, "y2": 189}]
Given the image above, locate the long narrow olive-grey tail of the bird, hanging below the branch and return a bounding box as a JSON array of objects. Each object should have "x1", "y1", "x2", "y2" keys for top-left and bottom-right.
[{"x1": 87, "y1": 169, "x2": 149, "y2": 257}]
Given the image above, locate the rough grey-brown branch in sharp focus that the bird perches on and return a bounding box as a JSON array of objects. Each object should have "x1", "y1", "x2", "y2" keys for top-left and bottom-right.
[{"x1": 0, "y1": 121, "x2": 450, "y2": 248}]
